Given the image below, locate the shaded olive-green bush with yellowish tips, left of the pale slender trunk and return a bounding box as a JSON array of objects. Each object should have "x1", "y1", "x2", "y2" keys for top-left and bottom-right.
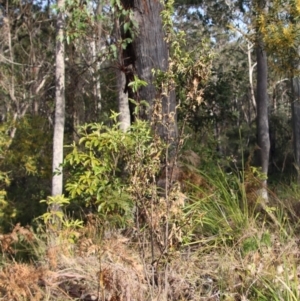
[{"x1": 0, "y1": 116, "x2": 52, "y2": 231}]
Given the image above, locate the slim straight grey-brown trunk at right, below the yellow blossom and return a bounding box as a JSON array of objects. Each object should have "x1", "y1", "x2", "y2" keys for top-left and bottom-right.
[{"x1": 256, "y1": 0, "x2": 270, "y2": 198}]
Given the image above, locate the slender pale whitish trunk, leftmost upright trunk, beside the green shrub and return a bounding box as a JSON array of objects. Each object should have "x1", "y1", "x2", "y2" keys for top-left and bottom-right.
[{"x1": 52, "y1": 0, "x2": 65, "y2": 202}]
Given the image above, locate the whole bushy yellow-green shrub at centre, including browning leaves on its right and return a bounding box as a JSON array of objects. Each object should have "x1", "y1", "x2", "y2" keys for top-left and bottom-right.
[{"x1": 65, "y1": 114, "x2": 163, "y2": 226}]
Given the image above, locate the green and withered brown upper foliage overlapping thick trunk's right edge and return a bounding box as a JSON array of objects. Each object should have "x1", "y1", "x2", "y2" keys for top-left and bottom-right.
[{"x1": 158, "y1": 0, "x2": 214, "y2": 120}]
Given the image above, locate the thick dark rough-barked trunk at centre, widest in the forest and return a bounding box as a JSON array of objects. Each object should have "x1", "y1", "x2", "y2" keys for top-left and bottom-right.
[{"x1": 122, "y1": 0, "x2": 177, "y2": 140}]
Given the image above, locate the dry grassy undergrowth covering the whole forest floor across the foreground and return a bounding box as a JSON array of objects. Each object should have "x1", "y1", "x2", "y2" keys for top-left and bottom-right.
[{"x1": 0, "y1": 166, "x2": 300, "y2": 301}]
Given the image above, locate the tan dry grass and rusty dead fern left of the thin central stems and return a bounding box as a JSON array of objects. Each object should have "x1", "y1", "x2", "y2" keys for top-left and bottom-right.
[{"x1": 0, "y1": 226, "x2": 147, "y2": 301}]
